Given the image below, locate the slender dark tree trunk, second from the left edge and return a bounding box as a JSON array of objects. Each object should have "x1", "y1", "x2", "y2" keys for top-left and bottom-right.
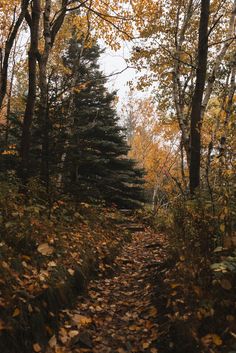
[{"x1": 19, "y1": 0, "x2": 41, "y2": 183}]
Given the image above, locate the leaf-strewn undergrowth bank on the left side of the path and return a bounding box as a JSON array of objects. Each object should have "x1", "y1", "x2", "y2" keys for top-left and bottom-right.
[{"x1": 0, "y1": 185, "x2": 133, "y2": 353}]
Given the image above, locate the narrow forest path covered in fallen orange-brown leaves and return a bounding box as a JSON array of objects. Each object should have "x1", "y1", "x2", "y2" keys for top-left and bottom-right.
[{"x1": 47, "y1": 231, "x2": 164, "y2": 353}]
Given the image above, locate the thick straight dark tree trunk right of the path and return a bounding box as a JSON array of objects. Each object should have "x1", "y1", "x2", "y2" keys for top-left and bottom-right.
[{"x1": 189, "y1": 0, "x2": 210, "y2": 195}]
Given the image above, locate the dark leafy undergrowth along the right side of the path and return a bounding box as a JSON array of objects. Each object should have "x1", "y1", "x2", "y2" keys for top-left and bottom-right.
[{"x1": 144, "y1": 197, "x2": 236, "y2": 353}]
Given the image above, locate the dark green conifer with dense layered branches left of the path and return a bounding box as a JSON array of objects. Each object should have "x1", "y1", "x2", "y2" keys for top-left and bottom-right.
[{"x1": 59, "y1": 38, "x2": 143, "y2": 207}]
